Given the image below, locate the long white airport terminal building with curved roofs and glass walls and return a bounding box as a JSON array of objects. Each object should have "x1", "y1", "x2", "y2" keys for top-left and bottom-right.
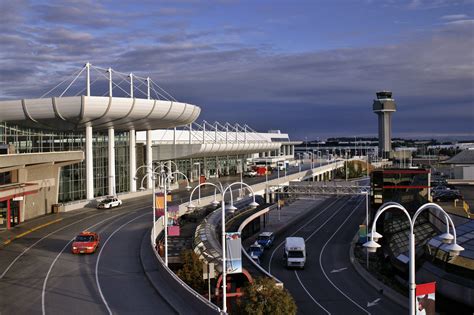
[{"x1": 0, "y1": 65, "x2": 298, "y2": 228}]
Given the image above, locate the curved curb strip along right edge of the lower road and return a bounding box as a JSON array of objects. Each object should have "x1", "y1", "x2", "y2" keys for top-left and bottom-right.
[{"x1": 349, "y1": 234, "x2": 408, "y2": 310}]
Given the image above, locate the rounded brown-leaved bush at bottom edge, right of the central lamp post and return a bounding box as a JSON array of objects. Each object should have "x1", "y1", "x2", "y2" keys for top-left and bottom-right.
[{"x1": 240, "y1": 277, "x2": 297, "y2": 315}]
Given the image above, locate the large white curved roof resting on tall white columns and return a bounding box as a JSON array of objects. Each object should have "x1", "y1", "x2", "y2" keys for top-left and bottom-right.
[{"x1": 0, "y1": 95, "x2": 201, "y2": 131}]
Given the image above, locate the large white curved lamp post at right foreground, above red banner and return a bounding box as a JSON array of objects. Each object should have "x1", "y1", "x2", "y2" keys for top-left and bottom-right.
[{"x1": 364, "y1": 202, "x2": 464, "y2": 315}]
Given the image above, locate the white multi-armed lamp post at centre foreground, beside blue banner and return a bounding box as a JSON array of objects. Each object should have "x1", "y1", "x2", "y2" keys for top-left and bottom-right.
[{"x1": 187, "y1": 182, "x2": 258, "y2": 314}]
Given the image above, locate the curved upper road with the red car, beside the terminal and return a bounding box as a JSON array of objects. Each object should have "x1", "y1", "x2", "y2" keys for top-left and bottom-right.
[{"x1": 0, "y1": 198, "x2": 174, "y2": 314}]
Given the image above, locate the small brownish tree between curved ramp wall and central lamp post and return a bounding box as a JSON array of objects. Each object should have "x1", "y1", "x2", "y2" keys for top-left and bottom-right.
[{"x1": 176, "y1": 249, "x2": 207, "y2": 292}]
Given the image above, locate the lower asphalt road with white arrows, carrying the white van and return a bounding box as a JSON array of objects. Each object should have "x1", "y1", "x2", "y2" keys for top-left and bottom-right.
[{"x1": 262, "y1": 196, "x2": 406, "y2": 314}]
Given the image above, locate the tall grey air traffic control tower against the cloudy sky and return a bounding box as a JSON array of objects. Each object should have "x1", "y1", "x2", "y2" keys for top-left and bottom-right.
[{"x1": 373, "y1": 91, "x2": 397, "y2": 158}]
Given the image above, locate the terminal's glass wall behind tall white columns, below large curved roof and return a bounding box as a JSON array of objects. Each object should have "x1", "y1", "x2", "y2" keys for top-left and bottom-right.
[{"x1": 0, "y1": 122, "x2": 130, "y2": 202}]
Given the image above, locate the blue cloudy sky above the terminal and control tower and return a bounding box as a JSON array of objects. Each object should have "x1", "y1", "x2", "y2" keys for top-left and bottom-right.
[{"x1": 0, "y1": 0, "x2": 474, "y2": 140}]
